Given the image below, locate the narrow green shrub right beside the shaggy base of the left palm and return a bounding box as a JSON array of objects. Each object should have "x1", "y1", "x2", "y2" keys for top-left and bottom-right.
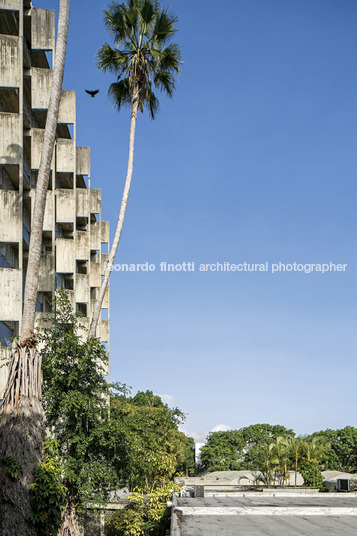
[{"x1": 28, "y1": 438, "x2": 67, "y2": 536}]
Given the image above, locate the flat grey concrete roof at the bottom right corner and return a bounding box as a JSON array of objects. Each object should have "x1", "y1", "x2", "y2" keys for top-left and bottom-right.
[{"x1": 171, "y1": 492, "x2": 357, "y2": 536}]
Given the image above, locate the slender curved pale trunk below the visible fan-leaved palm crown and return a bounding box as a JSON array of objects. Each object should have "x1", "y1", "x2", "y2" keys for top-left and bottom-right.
[{"x1": 88, "y1": 91, "x2": 139, "y2": 338}]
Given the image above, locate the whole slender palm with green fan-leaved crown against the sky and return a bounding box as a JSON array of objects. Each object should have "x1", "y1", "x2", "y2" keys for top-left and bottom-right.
[{"x1": 88, "y1": 0, "x2": 181, "y2": 337}]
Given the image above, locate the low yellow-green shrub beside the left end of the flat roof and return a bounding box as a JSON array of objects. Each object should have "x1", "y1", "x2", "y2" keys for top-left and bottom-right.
[{"x1": 107, "y1": 484, "x2": 180, "y2": 536}]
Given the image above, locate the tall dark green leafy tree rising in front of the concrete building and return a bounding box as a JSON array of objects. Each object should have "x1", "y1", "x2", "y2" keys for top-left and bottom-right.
[{"x1": 39, "y1": 291, "x2": 116, "y2": 509}]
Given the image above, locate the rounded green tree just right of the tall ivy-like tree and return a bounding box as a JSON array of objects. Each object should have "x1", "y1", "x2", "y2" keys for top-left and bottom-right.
[{"x1": 110, "y1": 391, "x2": 186, "y2": 493}]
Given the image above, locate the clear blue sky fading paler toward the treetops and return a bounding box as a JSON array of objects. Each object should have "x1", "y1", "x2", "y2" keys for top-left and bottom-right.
[{"x1": 33, "y1": 0, "x2": 357, "y2": 438}]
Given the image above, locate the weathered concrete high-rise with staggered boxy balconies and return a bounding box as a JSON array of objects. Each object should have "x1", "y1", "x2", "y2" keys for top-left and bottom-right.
[{"x1": 0, "y1": 0, "x2": 109, "y2": 398}]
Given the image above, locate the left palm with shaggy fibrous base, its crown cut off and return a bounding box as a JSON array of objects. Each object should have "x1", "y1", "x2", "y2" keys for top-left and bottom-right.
[{"x1": 0, "y1": 0, "x2": 70, "y2": 536}]
